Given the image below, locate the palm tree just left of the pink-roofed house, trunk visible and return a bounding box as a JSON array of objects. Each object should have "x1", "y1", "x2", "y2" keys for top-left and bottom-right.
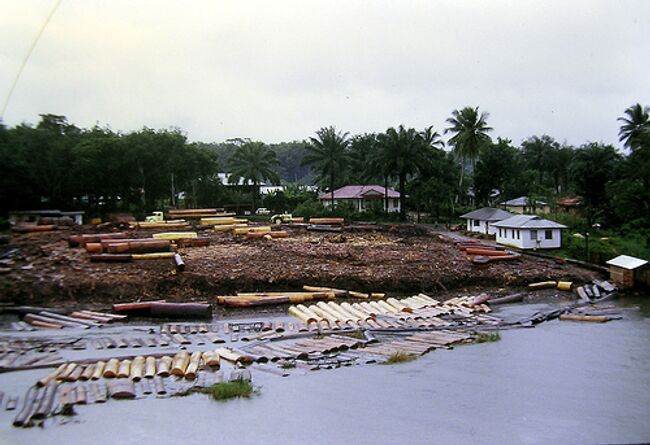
[{"x1": 300, "y1": 126, "x2": 350, "y2": 208}]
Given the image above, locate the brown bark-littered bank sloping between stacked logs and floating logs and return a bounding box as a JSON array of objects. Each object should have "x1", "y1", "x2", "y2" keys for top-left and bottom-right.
[{"x1": 0, "y1": 225, "x2": 593, "y2": 304}]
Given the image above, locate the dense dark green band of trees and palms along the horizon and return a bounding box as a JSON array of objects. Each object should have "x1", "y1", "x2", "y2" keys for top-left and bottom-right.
[{"x1": 0, "y1": 104, "x2": 650, "y2": 232}]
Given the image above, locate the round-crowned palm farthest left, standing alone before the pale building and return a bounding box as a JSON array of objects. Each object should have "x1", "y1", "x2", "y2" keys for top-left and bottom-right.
[{"x1": 228, "y1": 142, "x2": 280, "y2": 208}]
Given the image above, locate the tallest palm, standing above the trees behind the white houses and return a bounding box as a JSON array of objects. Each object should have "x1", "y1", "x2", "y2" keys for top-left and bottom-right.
[{"x1": 445, "y1": 107, "x2": 492, "y2": 192}]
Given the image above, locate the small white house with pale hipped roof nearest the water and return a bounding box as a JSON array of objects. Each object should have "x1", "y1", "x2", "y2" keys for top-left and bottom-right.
[{"x1": 492, "y1": 215, "x2": 567, "y2": 249}]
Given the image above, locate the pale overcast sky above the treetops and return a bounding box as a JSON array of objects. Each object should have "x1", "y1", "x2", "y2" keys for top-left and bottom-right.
[{"x1": 0, "y1": 0, "x2": 650, "y2": 146}]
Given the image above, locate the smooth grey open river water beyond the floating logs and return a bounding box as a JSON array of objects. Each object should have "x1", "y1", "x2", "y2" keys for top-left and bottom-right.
[{"x1": 0, "y1": 297, "x2": 650, "y2": 445}]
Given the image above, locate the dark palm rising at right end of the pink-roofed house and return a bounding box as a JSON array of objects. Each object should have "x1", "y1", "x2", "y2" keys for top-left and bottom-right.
[{"x1": 375, "y1": 125, "x2": 431, "y2": 221}]
